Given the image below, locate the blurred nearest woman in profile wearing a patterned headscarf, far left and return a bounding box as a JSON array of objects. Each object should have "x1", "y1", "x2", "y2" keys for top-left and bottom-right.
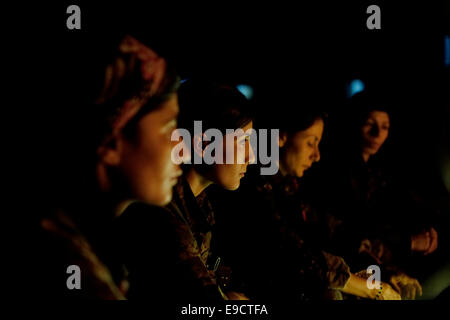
[{"x1": 37, "y1": 35, "x2": 181, "y2": 299}]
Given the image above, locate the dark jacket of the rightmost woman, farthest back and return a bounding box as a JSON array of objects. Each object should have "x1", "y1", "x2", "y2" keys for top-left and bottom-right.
[{"x1": 311, "y1": 157, "x2": 429, "y2": 275}]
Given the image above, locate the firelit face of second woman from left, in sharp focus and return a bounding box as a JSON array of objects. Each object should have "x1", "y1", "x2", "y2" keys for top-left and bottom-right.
[{"x1": 208, "y1": 122, "x2": 255, "y2": 190}]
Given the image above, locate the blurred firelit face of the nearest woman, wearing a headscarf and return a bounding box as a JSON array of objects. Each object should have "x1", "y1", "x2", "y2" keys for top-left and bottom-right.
[{"x1": 119, "y1": 94, "x2": 181, "y2": 205}]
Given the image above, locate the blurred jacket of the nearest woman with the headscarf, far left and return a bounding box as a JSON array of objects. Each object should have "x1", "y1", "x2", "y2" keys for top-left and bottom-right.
[{"x1": 38, "y1": 210, "x2": 128, "y2": 300}]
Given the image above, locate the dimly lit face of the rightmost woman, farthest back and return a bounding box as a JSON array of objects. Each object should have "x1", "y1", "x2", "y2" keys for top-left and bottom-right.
[{"x1": 361, "y1": 111, "x2": 390, "y2": 155}]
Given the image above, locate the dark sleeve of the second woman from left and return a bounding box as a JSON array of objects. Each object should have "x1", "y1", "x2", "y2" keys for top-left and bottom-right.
[{"x1": 114, "y1": 204, "x2": 223, "y2": 301}]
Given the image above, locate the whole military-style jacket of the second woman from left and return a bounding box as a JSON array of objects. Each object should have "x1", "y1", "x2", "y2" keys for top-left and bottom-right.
[{"x1": 116, "y1": 177, "x2": 225, "y2": 301}]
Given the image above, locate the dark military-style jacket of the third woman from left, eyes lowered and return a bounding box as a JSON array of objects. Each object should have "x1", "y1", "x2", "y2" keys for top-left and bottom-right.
[{"x1": 207, "y1": 168, "x2": 350, "y2": 300}]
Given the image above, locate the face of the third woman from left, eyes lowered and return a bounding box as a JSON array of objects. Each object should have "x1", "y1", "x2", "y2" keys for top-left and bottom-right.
[{"x1": 280, "y1": 119, "x2": 324, "y2": 177}]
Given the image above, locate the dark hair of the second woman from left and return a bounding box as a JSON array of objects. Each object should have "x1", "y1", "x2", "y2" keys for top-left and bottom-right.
[{"x1": 178, "y1": 79, "x2": 252, "y2": 133}]
